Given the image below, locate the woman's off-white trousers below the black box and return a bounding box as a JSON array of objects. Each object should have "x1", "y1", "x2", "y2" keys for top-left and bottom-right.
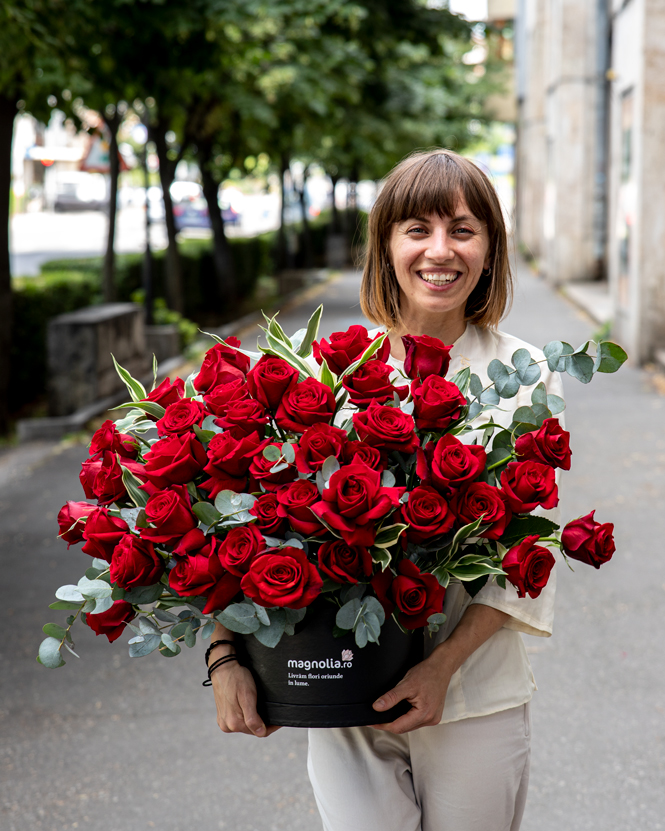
[{"x1": 307, "y1": 703, "x2": 531, "y2": 831}]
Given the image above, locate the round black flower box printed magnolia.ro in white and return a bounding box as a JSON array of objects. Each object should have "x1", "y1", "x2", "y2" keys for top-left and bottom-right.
[{"x1": 243, "y1": 600, "x2": 423, "y2": 727}]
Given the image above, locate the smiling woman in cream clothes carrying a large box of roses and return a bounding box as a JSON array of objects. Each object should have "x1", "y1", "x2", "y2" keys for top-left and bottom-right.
[{"x1": 211, "y1": 150, "x2": 561, "y2": 831}]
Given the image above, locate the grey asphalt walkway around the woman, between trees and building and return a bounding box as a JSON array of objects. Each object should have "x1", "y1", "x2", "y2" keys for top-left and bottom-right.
[{"x1": 0, "y1": 264, "x2": 665, "y2": 831}]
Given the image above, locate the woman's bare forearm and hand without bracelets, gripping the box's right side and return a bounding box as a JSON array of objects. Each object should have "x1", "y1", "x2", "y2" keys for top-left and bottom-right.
[{"x1": 373, "y1": 605, "x2": 510, "y2": 733}]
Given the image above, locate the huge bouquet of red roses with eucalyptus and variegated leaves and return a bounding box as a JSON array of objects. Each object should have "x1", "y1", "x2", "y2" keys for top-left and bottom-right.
[{"x1": 38, "y1": 307, "x2": 626, "y2": 667}]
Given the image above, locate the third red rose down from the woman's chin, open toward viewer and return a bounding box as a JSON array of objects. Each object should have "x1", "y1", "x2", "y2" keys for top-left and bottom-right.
[{"x1": 416, "y1": 436, "x2": 487, "y2": 491}]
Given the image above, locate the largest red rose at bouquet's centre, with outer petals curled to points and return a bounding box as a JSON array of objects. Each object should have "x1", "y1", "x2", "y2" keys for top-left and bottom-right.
[{"x1": 312, "y1": 464, "x2": 404, "y2": 547}]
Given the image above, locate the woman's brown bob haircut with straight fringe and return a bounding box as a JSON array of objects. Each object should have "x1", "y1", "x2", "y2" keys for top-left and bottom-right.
[{"x1": 360, "y1": 149, "x2": 513, "y2": 329}]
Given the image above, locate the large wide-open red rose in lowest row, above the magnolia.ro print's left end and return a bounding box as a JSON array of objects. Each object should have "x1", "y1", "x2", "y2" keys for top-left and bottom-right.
[{"x1": 240, "y1": 546, "x2": 323, "y2": 609}]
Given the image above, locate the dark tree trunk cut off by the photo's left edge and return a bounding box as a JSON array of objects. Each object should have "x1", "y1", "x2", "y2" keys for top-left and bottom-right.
[{"x1": 0, "y1": 95, "x2": 16, "y2": 435}]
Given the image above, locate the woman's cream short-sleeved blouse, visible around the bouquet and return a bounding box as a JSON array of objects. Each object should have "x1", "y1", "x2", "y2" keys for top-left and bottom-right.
[{"x1": 370, "y1": 324, "x2": 563, "y2": 724}]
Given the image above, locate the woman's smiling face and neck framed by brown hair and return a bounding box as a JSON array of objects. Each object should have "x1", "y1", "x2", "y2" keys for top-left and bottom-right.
[{"x1": 389, "y1": 199, "x2": 490, "y2": 320}]
